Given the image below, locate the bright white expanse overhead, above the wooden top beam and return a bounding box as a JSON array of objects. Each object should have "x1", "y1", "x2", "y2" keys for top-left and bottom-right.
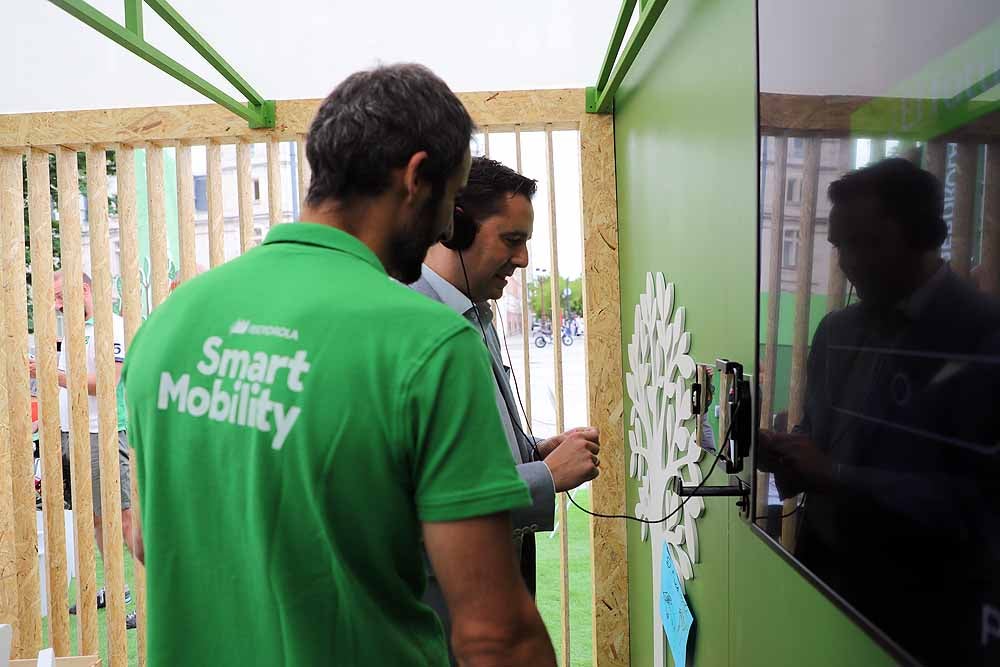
[{"x1": 0, "y1": 0, "x2": 618, "y2": 113}]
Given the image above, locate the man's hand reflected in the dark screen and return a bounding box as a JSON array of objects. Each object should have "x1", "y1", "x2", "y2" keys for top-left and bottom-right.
[{"x1": 757, "y1": 431, "x2": 837, "y2": 498}]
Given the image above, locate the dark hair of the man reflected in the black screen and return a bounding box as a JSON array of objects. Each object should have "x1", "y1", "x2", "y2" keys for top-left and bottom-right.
[{"x1": 827, "y1": 158, "x2": 948, "y2": 250}]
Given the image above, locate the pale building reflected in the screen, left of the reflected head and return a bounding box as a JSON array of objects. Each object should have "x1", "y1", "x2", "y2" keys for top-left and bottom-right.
[{"x1": 760, "y1": 137, "x2": 851, "y2": 294}]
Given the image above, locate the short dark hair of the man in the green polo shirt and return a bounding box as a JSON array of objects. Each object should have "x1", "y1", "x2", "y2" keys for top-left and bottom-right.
[{"x1": 306, "y1": 64, "x2": 473, "y2": 206}]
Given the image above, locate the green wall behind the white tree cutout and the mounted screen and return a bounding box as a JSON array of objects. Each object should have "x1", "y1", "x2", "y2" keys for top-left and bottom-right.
[{"x1": 615, "y1": 0, "x2": 891, "y2": 667}]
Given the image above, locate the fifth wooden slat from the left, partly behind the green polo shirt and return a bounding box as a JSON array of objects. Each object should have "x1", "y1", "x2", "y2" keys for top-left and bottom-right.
[{"x1": 114, "y1": 145, "x2": 146, "y2": 667}]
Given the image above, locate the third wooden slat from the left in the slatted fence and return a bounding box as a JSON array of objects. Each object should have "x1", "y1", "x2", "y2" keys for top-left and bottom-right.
[{"x1": 50, "y1": 148, "x2": 98, "y2": 653}]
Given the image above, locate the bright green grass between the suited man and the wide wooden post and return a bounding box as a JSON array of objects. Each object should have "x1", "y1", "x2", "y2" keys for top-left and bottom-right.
[{"x1": 535, "y1": 489, "x2": 594, "y2": 667}]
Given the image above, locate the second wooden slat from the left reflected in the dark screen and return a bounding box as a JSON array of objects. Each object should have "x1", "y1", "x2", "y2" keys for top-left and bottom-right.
[{"x1": 781, "y1": 137, "x2": 820, "y2": 550}]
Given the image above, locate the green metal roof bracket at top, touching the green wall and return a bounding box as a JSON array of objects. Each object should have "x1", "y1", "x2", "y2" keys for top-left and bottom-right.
[{"x1": 587, "y1": 0, "x2": 668, "y2": 113}]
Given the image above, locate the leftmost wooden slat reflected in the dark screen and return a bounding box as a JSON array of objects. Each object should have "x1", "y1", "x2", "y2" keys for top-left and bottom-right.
[{"x1": 756, "y1": 137, "x2": 788, "y2": 518}]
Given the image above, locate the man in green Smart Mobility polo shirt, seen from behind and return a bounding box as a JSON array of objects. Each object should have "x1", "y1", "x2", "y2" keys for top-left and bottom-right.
[{"x1": 124, "y1": 65, "x2": 555, "y2": 667}]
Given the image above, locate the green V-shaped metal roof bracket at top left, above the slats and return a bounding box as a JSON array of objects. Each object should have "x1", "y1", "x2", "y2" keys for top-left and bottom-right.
[{"x1": 49, "y1": 0, "x2": 275, "y2": 128}]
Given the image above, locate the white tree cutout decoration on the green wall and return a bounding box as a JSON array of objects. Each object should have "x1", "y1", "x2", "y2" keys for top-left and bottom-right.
[{"x1": 625, "y1": 273, "x2": 705, "y2": 667}]
